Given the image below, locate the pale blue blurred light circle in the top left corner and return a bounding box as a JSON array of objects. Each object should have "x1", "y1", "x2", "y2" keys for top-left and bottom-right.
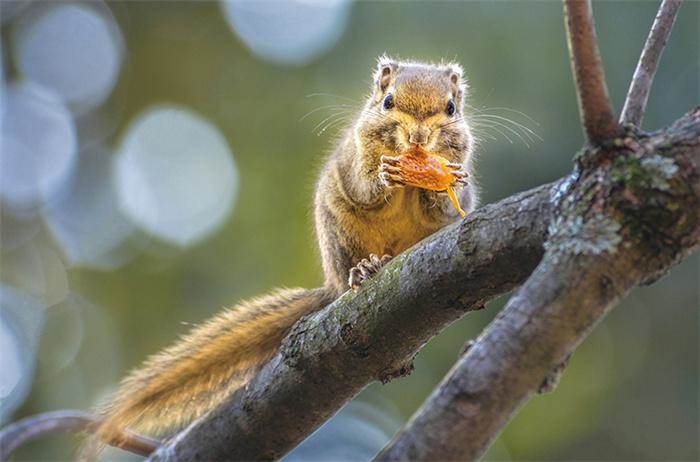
[{"x1": 13, "y1": 4, "x2": 123, "y2": 110}]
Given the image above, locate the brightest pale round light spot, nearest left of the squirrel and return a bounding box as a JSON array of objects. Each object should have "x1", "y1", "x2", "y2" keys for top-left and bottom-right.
[{"x1": 114, "y1": 106, "x2": 238, "y2": 246}]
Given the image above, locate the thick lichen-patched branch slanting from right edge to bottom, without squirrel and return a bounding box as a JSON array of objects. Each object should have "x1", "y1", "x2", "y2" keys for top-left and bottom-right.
[{"x1": 376, "y1": 109, "x2": 700, "y2": 461}]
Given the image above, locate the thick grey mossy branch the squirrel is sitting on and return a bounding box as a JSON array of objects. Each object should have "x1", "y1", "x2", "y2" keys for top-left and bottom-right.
[{"x1": 145, "y1": 185, "x2": 553, "y2": 461}]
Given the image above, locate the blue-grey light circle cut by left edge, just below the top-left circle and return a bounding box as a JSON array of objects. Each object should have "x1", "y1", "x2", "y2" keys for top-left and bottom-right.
[{"x1": 0, "y1": 83, "x2": 77, "y2": 209}]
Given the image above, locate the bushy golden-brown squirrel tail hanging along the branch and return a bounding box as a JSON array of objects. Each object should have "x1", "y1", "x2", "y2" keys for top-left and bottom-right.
[{"x1": 81, "y1": 288, "x2": 332, "y2": 459}]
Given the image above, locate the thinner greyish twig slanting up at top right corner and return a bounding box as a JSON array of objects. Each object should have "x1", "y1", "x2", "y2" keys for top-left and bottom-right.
[{"x1": 620, "y1": 0, "x2": 681, "y2": 126}]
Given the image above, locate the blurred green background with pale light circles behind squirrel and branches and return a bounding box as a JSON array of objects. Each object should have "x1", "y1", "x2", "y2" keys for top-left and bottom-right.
[{"x1": 0, "y1": 0, "x2": 700, "y2": 461}]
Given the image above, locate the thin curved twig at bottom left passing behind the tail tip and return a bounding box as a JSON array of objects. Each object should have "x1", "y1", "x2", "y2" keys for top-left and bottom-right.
[{"x1": 0, "y1": 409, "x2": 160, "y2": 460}]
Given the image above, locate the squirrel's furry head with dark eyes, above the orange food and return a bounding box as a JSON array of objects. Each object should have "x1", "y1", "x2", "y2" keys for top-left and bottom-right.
[{"x1": 356, "y1": 57, "x2": 473, "y2": 161}]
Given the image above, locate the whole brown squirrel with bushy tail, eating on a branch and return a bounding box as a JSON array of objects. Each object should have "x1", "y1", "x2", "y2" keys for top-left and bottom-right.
[{"x1": 83, "y1": 56, "x2": 477, "y2": 458}]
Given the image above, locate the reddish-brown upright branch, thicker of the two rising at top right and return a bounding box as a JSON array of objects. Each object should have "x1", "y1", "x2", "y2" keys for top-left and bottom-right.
[{"x1": 564, "y1": 0, "x2": 621, "y2": 144}]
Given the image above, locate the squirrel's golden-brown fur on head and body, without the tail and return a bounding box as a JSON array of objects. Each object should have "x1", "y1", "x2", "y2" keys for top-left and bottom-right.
[{"x1": 315, "y1": 58, "x2": 477, "y2": 293}]
